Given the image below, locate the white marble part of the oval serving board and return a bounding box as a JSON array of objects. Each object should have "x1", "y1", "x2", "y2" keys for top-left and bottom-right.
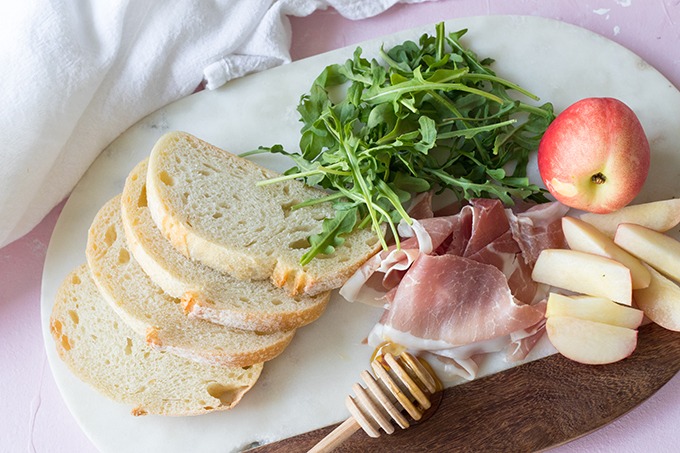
[{"x1": 41, "y1": 16, "x2": 680, "y2": 453}]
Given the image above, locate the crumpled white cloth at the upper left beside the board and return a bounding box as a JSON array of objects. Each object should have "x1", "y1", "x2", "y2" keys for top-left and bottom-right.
[{"x1": 0, "y1": 0, "x2": 424, "y2": 247}]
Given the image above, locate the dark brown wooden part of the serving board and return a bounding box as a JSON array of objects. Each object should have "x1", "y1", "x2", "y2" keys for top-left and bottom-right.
[{"x1": 252, "y1": 324, "x2": 680, "y2": 453}]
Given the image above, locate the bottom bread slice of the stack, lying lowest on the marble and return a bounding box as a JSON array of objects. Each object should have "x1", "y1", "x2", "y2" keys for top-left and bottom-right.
[{"x1": 50, "y1": 265, "x2": 262, "y2": 415}]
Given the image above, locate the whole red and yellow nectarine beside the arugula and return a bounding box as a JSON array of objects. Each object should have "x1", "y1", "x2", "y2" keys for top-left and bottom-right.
[{"x1": 538, "y1": 98, "x2": 650, "y2": 213}]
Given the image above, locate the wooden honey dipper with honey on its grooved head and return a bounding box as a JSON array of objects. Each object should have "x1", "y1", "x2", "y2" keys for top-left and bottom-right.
[{"x1": 308, "y1": 352, "x2": 440, "y2": 453}]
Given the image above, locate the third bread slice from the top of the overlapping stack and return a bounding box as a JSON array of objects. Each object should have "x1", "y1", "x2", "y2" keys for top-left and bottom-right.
[{"x1": 86, "y1": 195, "x2": 294, "y2": 366}]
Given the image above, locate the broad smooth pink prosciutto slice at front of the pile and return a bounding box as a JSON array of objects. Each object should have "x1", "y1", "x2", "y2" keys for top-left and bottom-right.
[{"x1": 381, "y1": 255, "x2": 543, "y2": 349}]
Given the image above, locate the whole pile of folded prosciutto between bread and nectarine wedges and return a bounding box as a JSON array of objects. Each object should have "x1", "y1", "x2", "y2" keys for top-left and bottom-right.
[{"x1": 341, "y1": 199, "x2": 568, "y2": 379}]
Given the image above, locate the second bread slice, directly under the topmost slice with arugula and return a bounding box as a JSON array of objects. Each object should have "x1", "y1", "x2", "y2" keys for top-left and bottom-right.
[{"x1": 121, "y1": 160, "x2": 329, "y2": 332}]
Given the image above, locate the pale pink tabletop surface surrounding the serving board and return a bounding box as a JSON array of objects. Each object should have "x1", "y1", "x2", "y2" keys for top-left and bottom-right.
[{"x1": 0, "y1": 0, "x2": 680, "y2": 452}]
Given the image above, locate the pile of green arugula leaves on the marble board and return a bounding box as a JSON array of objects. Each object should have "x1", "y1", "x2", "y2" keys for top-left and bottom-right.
[{"x1": 247, "y1": 23, "x2": 554, "y2": 265}]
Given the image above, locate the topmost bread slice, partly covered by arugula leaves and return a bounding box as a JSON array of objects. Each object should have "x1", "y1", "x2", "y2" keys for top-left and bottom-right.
[{"x1": 146, "y1": 132, "x2": 380, "y2": 294}]
